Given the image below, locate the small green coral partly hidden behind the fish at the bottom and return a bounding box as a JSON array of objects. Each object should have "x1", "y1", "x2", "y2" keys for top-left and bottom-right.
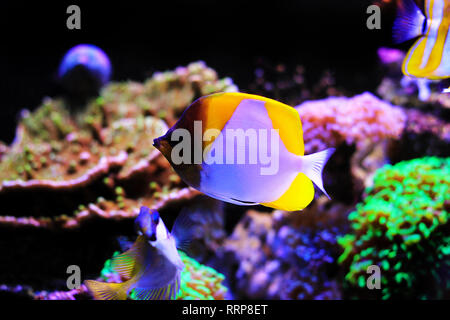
[{"x1": 96, "y1": 251, "x2": 228, "y2": 300}]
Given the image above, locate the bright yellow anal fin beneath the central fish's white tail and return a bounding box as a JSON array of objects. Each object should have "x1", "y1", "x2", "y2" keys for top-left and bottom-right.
[{"x1": 261, "y1": 172, "x2": 314, "y2": 211}]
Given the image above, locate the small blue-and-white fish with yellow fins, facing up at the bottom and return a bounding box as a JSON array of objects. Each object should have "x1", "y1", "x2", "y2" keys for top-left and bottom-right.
[{"x1": 85, "y1": 207, "x2": 196, "y2": 300}]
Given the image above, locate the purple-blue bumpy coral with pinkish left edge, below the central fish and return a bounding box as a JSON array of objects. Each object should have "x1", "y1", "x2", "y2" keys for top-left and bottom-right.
[{"x1": 217, "y1": 198, "x2": 350, "y2": 299}]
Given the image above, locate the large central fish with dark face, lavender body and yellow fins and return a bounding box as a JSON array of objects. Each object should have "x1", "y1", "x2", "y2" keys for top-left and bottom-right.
[{"x1": 154, "y1": 93, "x2": 334, "y2": 211}]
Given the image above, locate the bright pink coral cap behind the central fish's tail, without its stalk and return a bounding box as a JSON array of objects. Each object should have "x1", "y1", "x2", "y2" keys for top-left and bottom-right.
[{"x1": 296, "y1": 92, "x2": 405, "y2": 153}]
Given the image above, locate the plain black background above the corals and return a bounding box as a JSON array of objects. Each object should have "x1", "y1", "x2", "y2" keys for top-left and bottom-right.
[{"x1": 0, "y1": 0, "x2": 391, "y2": 143}]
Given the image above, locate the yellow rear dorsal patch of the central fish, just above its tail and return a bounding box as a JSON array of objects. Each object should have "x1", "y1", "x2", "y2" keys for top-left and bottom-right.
[{"x1": 264, "y1": 99, "x2": 304, "y2": 156}]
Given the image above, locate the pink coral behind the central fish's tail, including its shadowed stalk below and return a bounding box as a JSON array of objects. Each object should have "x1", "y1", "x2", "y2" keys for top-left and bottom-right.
[{"x1": 296, "y1": 92, "x2": 405, "y2": 202}]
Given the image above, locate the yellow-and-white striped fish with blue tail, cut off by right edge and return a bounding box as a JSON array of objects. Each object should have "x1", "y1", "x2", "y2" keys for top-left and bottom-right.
[{"x1": 394, "y1": 0, "x2": 450, "y2": 92}]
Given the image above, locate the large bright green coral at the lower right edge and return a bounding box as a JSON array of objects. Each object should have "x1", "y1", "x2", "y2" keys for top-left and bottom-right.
[{"x1": 338, "y1": 157, "x2": 450, "y2": 299}]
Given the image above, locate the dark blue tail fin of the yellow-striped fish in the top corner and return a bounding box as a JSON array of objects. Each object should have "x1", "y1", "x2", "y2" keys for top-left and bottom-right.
[{"x1": 392, "y1": 0, "x2": 426, "y2": 43}]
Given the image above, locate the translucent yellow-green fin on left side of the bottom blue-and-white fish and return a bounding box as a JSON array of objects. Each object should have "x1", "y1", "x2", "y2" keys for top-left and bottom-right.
[{"x1": 111, "y1": 235, "x2": 146, "y2": 279}]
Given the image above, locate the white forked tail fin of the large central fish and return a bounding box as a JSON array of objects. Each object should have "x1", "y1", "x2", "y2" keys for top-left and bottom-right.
[{"x1": 301, "y1": 148, "x2": 335, "y2": 199}]
